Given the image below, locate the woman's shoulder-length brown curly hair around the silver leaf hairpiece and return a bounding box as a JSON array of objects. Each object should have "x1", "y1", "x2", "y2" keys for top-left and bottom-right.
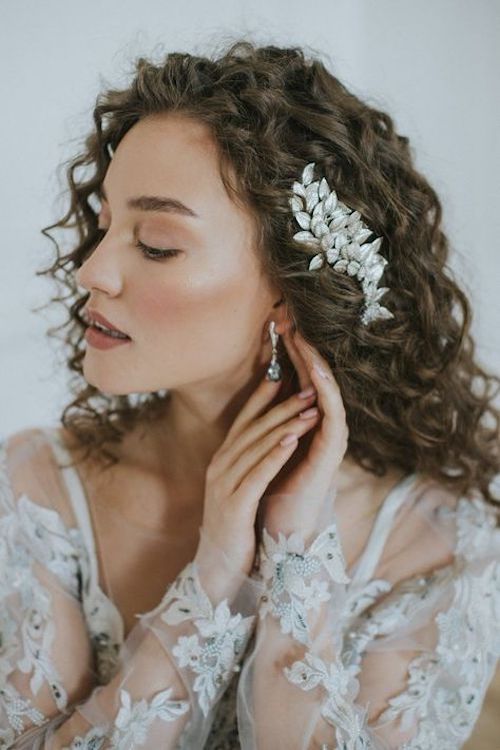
[{"x1": 37, "y1": 39, "x2": 500, "y2": 516}]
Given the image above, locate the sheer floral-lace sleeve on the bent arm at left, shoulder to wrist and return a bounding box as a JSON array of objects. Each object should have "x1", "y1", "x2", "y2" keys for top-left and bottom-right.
[{"x1": 0, "y1": 434, "x2": 261, "y2": 750}]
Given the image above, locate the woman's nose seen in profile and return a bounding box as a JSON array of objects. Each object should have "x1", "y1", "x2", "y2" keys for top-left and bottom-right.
[{"x1": 75, "y1": 231, "x2": 127, "y2": 296}]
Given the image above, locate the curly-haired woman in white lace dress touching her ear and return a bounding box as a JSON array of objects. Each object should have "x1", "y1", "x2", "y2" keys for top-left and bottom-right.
[{"x1": 0, "y1": 41, "x2": 500, "y2": 750}]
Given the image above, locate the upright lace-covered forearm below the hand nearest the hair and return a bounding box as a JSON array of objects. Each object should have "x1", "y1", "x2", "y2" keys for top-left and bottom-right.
[{"x1": 235, "y1": 527, "x2": 354, "y2": 750}]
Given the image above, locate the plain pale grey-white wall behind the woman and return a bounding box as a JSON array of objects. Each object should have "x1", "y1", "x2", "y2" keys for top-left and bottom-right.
[{"x1": 0, "y1": 0, "x2": 500, "y2": 433}]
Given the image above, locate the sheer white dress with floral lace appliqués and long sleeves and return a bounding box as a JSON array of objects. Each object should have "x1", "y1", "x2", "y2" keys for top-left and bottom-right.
[{"x1": 0, "y1": 428, "x2": 500, "y2": 750}]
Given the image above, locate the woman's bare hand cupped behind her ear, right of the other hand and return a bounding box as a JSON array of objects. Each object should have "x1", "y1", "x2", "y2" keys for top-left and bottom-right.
[{"x1": 262, "y1": 332, "x2": 349, "y2": 539}]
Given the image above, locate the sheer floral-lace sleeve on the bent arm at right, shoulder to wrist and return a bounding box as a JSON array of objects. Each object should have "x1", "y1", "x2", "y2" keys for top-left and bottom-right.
[{"x1": 238, "y1": 484, "x2": 500, "y2": 750}]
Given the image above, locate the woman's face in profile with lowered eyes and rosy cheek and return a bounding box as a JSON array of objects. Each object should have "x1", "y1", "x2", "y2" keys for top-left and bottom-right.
[{"x1": 76, "y1": 114, "x2": 281, "y2": 395}]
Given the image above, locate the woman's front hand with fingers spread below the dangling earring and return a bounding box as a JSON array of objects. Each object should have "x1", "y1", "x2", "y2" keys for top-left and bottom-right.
[{"x1": 195, "y1": 342, "x2": 326, "y2": 593}]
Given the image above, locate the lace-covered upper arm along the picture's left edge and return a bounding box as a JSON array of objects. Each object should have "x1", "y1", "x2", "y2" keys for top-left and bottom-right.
[{"x1": 0, "y1": 432, "x2": 92, "y2": 748}]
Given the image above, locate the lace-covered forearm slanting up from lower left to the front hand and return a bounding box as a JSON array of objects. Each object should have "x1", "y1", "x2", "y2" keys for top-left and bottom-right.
[{"x1": 43, "y1": 532, "x2": 261, "y2": 750}]
